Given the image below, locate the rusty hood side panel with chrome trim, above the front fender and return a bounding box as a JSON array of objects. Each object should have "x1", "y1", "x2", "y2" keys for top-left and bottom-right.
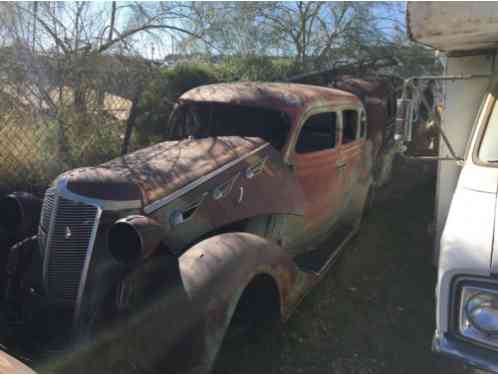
[{"x1": 152, "y1": 141, "x2": 305, "y2": 251}]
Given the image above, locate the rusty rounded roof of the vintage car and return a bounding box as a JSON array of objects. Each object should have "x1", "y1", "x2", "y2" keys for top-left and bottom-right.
[{"x1": 178, "y1": 82, "x2": 359, "y2": 112}]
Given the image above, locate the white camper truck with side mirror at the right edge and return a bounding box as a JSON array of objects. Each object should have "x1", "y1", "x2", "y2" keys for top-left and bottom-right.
[{"x1": 396, "y1": 2, "x2": 498, "y2": 372}]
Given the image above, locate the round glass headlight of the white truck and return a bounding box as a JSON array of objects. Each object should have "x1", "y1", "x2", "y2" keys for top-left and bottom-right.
[{"x1": 465, "y1": 293, "x2": 498, "y2": 335}]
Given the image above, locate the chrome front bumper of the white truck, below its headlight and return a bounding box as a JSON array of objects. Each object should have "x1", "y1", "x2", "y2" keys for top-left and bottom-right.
[{"x1": 432, "y1": 332, "x2": 498, "y2": 373}]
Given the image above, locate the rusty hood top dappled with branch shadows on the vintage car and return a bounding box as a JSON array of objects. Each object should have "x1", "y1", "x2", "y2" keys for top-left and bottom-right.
[{"x1": 55, "y1": 137, "x2": 266, "y2": 207}]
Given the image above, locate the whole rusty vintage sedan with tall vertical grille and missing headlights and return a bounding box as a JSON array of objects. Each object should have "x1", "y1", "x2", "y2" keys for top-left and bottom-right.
[{"x1": 0, "y1": 83, "x2": 389, "y2": 372}]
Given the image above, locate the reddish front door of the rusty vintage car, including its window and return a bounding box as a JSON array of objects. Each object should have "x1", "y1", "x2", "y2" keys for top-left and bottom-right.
[{"x1": 290, "y1": 110, "x2": 345, "y2": 250}]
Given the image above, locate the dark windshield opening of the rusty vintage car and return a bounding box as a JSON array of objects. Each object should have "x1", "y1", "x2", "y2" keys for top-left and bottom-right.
[{"x1": 169, "y1": 102, "x2": 290, "y2": 150}]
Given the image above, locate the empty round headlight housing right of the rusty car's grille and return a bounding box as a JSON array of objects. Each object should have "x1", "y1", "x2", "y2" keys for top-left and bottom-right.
[{"x1": 107, "y1": 215, "x2": 164, "y2": 265}]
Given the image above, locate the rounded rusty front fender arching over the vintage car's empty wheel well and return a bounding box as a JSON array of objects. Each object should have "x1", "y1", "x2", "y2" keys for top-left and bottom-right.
[{"x1": 179, "y1": 233, "x2": 302, "y2": 372}]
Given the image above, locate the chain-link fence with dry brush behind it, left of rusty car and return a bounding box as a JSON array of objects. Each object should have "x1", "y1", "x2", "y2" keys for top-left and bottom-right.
[{"x1": 0, "y1": 52, "x2": 160, "y2": 193}]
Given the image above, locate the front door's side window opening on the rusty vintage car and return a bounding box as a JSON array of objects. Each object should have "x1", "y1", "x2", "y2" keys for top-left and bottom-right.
[{"x1": 296, "y1": 112, "x2": 337, "y2": 154}]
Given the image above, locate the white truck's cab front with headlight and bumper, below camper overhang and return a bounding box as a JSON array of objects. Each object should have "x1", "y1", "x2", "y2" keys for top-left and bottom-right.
[{"x1": 433, "y1": 80, "x2": 498, "y2": 371}]
